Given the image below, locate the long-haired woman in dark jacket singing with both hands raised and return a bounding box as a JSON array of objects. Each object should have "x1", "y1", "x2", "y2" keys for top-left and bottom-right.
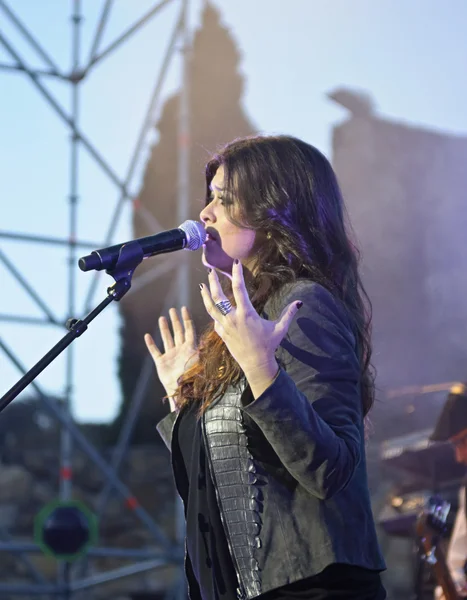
[{"x1": 145, "y1": 136, "x2": 386, "y2": 600}]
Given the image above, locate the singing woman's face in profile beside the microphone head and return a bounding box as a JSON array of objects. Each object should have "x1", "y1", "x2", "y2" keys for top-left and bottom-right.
[{"x1": 200, "y1": 166, "x2": 256, "y2": 273}]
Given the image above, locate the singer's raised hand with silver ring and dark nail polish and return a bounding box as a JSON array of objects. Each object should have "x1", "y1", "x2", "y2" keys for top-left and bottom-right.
[{"x1": 200, "y1": 261, "x2": 302, "y2": 383}]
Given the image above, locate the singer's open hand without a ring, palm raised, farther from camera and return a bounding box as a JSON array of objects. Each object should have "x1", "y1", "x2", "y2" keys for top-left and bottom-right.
[{"x1": 144, "y1": 306, "x2": 198, "y2": 410}]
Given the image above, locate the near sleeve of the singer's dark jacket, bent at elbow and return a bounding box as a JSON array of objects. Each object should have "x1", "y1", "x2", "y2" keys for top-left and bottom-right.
[{"x1": 242, "y1": 282, "x2": 364, "y2": 499}]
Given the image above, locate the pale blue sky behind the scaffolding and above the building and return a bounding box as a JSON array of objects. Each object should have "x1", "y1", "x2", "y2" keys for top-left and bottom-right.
[{"x1": 0, "y1": 0, "x2": 467, "y2": 422}]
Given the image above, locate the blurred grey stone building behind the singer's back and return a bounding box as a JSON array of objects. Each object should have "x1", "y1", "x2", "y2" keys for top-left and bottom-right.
[{"x1": 332, "y1": 92, "x2": 467, "y2": 398}]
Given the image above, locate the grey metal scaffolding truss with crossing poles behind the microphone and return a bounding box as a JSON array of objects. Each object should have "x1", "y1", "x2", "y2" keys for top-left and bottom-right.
[{"x1": 0, "y1": 0, "x2": 190, "y2": 598}]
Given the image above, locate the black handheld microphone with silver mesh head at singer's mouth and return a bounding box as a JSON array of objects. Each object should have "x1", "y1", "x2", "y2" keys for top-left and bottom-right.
[{"x1": 78, "y1": 221, "x2": 206, "y2": 271}]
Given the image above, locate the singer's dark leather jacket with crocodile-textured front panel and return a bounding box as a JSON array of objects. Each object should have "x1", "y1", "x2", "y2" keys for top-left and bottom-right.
[{"x1": 158, "y1": 280, "x2": 385, "y2": 600}]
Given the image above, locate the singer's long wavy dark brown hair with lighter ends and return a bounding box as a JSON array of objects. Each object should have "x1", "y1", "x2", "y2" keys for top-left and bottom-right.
[{"x1": 175, "y1": 136, "x2": 374, "y2": 415}]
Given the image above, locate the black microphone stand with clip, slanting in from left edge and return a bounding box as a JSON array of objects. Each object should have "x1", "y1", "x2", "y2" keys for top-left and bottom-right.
[{"x1": 0, "y1": 241, "x2": 144, "y2": 412}]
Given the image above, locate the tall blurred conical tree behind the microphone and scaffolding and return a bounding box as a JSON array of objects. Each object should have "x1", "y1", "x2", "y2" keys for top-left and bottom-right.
[{"x1": 111, "y1": 3, "x2": 254, "y2": 443}]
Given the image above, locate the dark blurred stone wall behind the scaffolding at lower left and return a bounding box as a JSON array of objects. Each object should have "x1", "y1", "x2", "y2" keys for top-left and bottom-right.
[{"x1": 0, "y1": 411, "x2": 179, "y2": 600}]
